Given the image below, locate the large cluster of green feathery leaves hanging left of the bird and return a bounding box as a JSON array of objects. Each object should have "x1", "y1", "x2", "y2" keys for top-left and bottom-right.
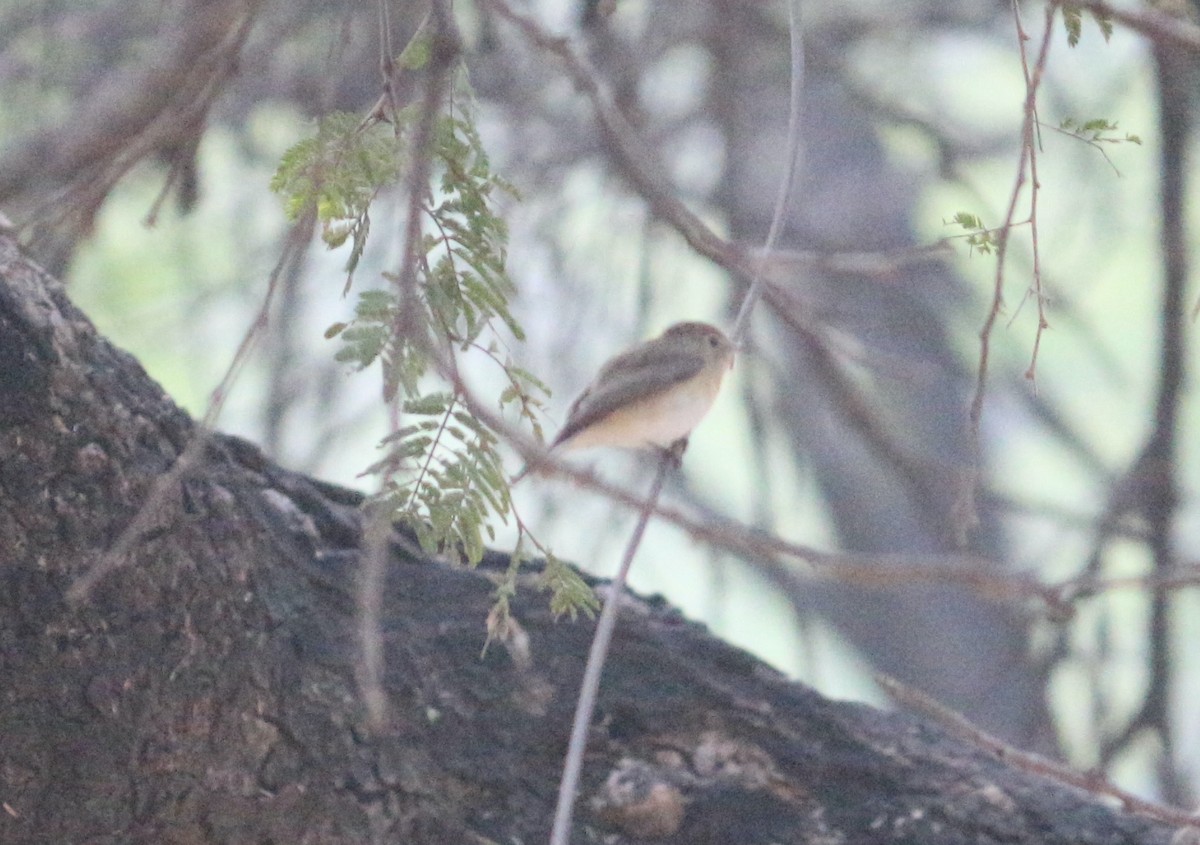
[{"x1": 272, "y1": 21, "x2": 594, "y2": 634}]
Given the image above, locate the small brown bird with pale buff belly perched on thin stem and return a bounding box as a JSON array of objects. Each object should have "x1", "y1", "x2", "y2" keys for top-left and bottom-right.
[{"x1": 514, "y1": 323, "x2": 733, "y2": 481}]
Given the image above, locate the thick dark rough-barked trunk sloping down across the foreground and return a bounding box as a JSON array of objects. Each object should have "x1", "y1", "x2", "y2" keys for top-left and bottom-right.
[{"x1": 0, "y1": 232, "x2": 1174, "y2": 845}]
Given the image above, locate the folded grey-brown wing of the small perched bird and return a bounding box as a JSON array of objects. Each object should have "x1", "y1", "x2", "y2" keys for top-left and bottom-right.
[{"x1": 551, "y1": 344, "x2": 704, "y2": 448}]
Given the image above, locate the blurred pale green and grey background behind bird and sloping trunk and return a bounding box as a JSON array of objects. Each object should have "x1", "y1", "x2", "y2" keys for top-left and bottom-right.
[{"x1": 0, "y1": 0, "x2": 1200, "y2": 807}]
